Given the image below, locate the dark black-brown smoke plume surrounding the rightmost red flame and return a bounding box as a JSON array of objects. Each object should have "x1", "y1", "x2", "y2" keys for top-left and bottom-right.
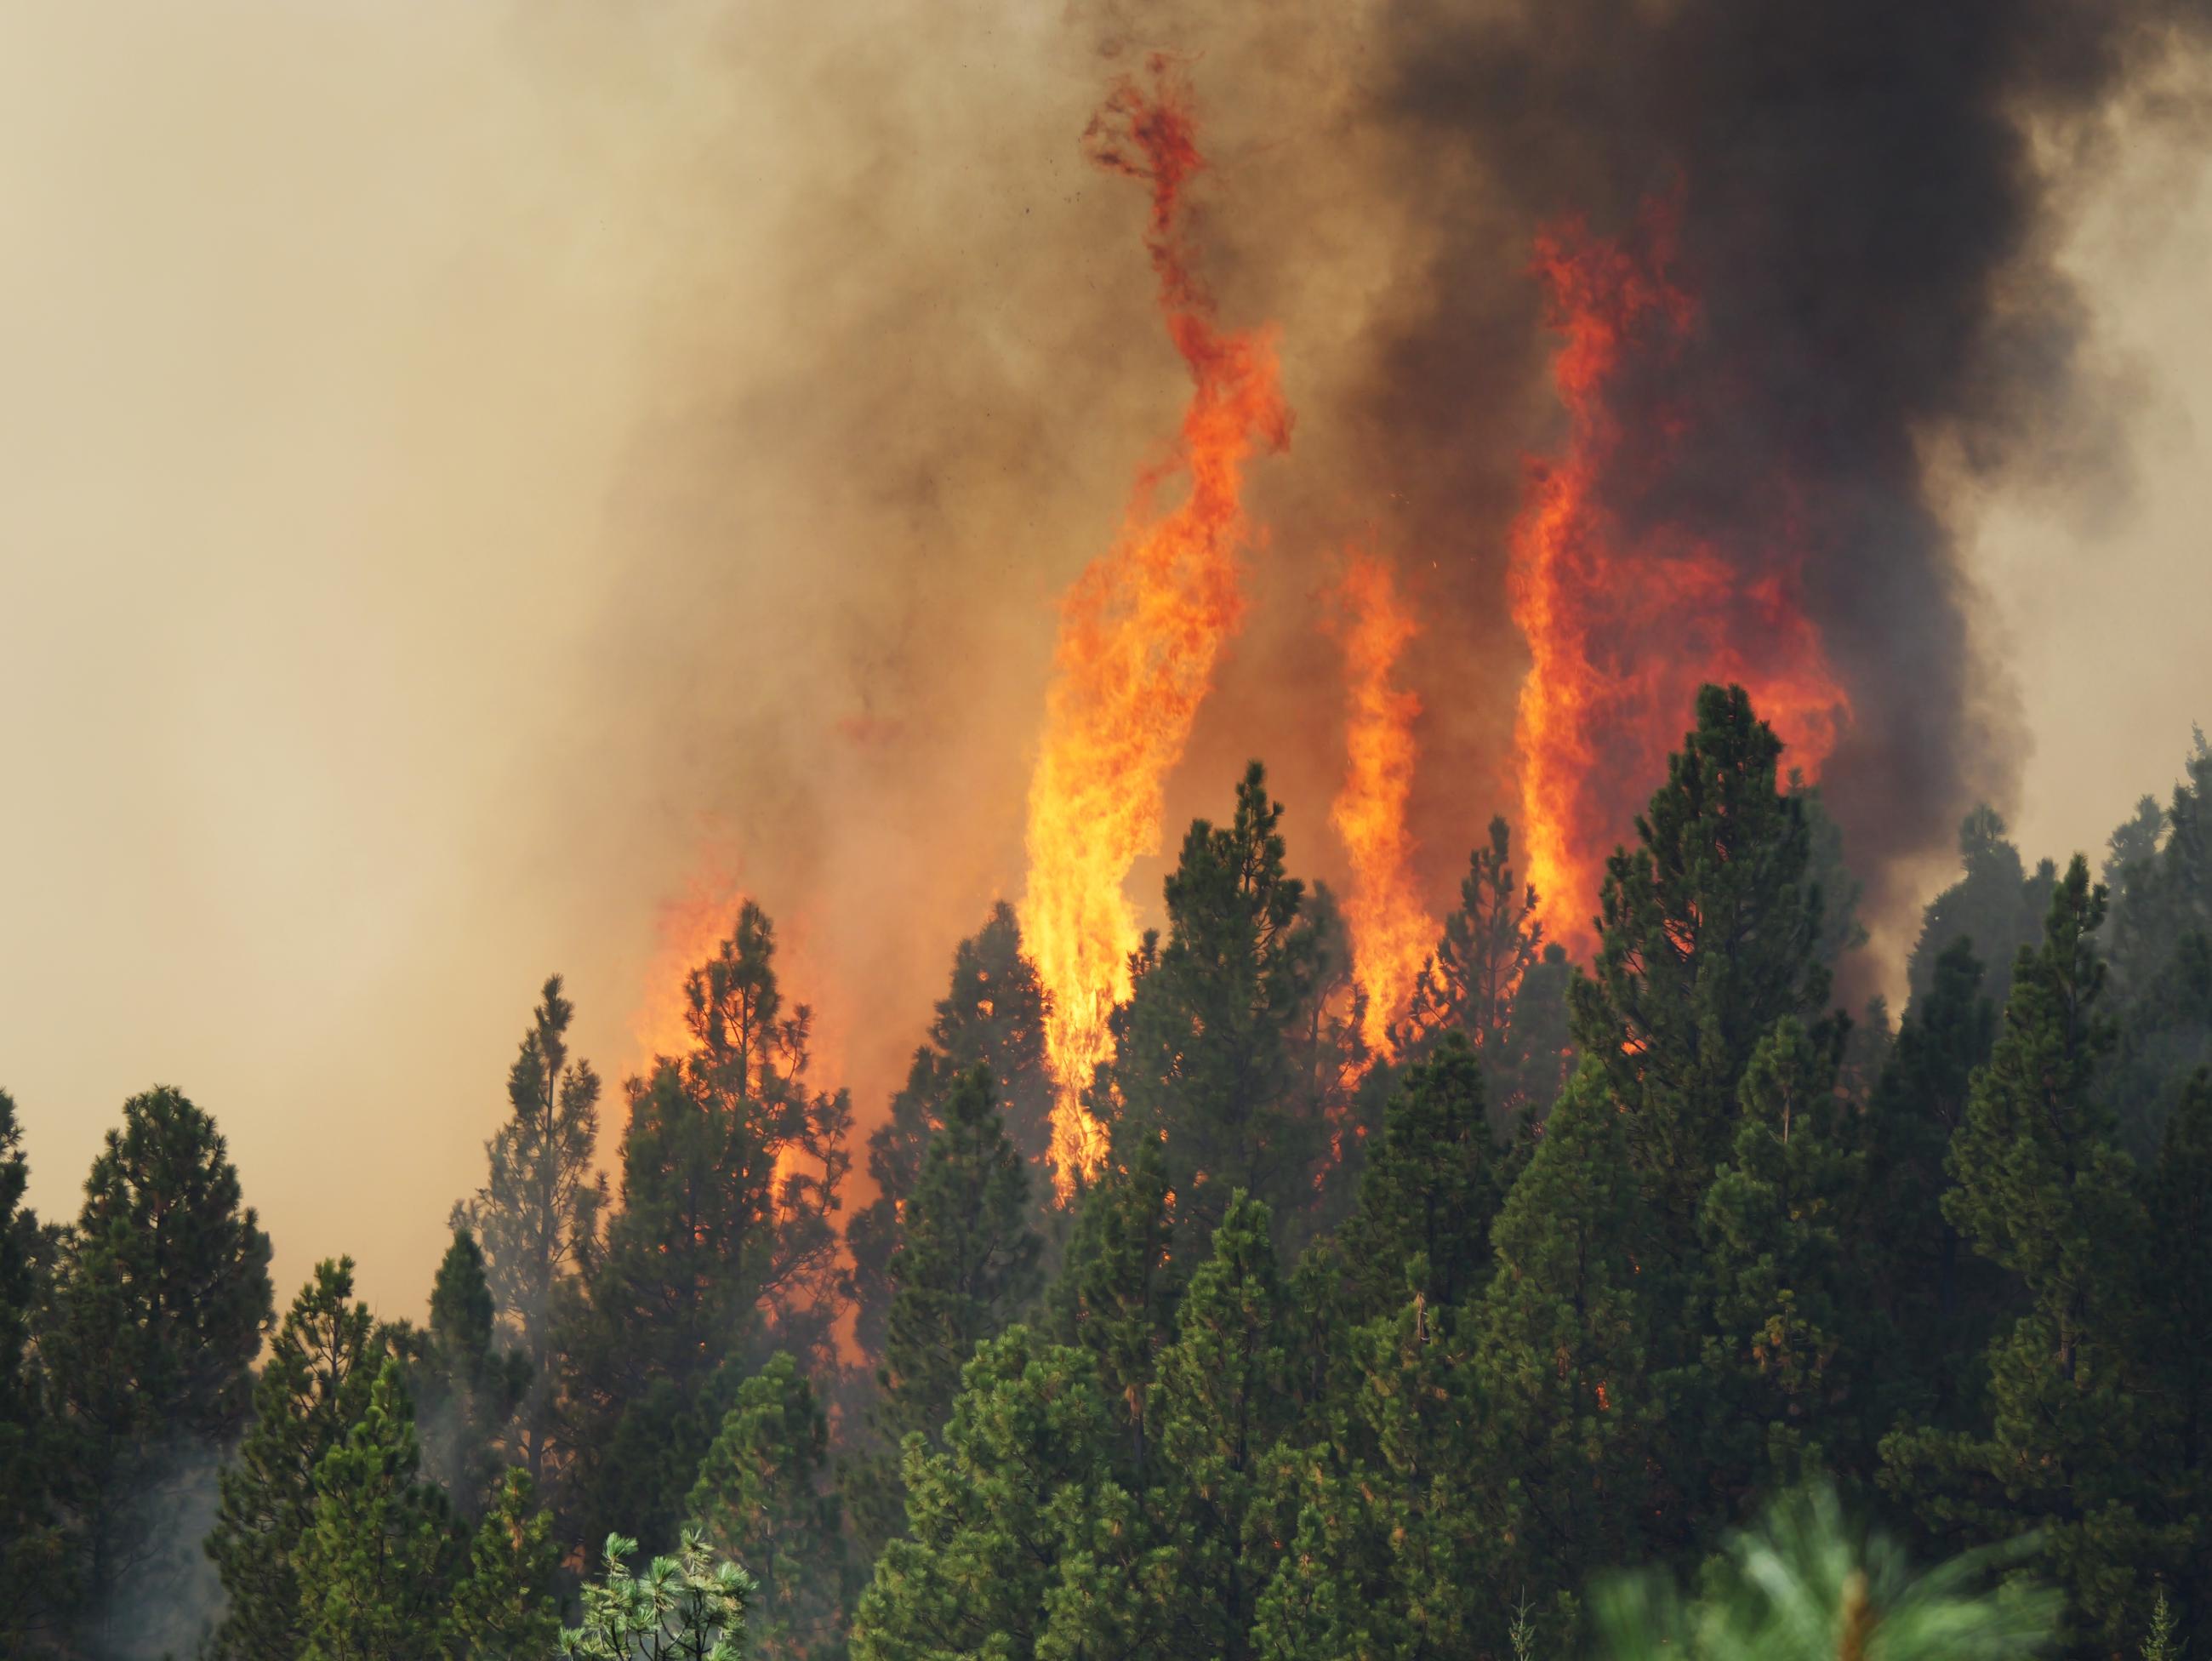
[{"x1": 1369, "y1": 0, "x2": 2208, "y2": 955}]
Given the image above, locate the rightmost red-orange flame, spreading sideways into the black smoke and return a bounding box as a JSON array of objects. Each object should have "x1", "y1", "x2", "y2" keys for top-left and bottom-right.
[{"x1": 1508, "y1": 202, "x2": 1850, "y2": 953}]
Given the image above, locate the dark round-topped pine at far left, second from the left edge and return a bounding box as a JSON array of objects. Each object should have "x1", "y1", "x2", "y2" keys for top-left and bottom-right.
[{"x1": 40, "y1": 1088, "x2": 272, "y2": 1645}]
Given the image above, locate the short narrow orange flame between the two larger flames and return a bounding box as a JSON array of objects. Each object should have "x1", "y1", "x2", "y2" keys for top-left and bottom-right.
[{"x1": 1330, "y1": 553, "x2": 1438, "y2": 1051}]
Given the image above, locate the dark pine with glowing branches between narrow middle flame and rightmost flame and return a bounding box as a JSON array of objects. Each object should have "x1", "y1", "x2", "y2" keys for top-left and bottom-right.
[{"x1": 1391, "y1": 819, "x2": 1571, "y2": 1122}]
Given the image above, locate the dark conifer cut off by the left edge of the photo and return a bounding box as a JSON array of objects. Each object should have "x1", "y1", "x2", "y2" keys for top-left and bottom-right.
[{"x1": 0, "y1": 1090, "x2": 62, "y2": 1654}]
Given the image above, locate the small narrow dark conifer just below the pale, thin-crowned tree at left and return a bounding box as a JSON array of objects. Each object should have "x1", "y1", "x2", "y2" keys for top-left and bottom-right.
[{"x1": 412, "y1": 1228, "x2": 531, "y2": 1521}]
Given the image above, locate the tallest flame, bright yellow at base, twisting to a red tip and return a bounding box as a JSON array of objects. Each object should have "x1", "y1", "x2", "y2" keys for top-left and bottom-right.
[{"x1": 1022, "y1": 58, "x2": 1290, "y2": 1199}]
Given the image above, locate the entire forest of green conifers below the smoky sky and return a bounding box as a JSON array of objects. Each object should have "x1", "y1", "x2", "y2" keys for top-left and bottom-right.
[{"x1": 0, "y1": 688, "x2": 2212, "y2": 1661}]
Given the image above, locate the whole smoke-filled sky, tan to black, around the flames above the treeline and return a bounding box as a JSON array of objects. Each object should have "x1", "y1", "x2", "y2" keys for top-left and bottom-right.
[{"x1": 0, "y1": 0, "x2": 2212, "y2": 1314}]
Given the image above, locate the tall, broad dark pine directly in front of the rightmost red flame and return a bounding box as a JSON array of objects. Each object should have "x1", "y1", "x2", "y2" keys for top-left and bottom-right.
[{"x1": 1573, "y1": 686, "x2": 1829, "y2": 1296}]
